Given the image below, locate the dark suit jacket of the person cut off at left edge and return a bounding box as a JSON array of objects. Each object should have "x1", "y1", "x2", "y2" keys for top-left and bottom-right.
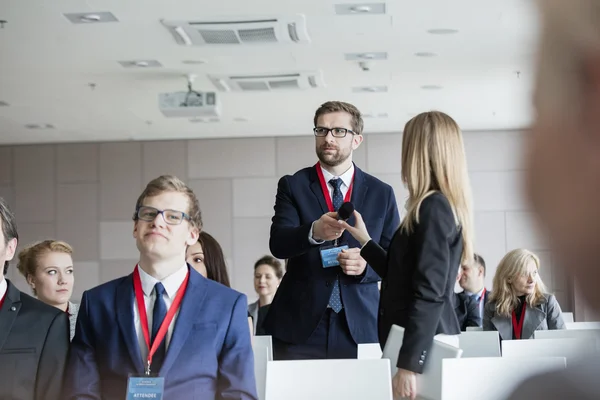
[{"x1": 0, "y1": 280, "x2": 69, "y2": 400}]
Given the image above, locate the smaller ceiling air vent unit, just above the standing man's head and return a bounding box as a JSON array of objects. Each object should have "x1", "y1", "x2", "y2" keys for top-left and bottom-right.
[{"x1": 208, "y1": 71, "x2": 325, "y2": 92}]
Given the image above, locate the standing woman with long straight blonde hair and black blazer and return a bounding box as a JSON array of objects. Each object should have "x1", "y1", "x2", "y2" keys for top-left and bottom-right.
[{"x1": 339, "y1": 111, "x2": 473, "y2": 399}]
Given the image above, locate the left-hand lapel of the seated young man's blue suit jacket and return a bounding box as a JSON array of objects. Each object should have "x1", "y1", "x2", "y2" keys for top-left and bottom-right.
[{"x1": 115, "y1": 274, "x2": 144, "y2": 373}]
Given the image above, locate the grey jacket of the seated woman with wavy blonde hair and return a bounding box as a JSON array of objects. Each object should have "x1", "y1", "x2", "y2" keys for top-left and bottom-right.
[{"x1": 483, "y1": 294, "x2": 566, "y2": 340}]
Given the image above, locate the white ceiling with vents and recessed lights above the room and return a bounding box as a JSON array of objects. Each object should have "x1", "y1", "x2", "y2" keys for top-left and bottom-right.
[{"x1": 0, "y1": 0, "x2": 537, "y2": 144}]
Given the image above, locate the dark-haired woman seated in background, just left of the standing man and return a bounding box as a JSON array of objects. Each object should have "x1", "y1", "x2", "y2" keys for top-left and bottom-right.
[{"x1": 248, "y1": 256, "x2": 283, "y2": 335}]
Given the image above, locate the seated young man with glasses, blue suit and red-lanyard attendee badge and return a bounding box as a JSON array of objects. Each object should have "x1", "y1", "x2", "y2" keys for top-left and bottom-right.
[{"x1": 62, "y1": 176, "x2": 256, "y2": 400}]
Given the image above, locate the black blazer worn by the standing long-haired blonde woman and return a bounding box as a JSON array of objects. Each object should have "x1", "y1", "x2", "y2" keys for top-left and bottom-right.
[{"x1": 361, "y1": 192, "x2": 463, "y2": 373}]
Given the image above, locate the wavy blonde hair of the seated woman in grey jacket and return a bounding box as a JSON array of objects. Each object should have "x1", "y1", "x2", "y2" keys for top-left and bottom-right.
[{"x1": 490, "y1": 249, "x2": 548, "y2": 316}]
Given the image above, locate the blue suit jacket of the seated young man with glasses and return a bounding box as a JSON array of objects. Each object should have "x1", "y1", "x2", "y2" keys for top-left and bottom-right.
[{"x1": 61, "y1": 267, "x2": 257, "y2": 400}]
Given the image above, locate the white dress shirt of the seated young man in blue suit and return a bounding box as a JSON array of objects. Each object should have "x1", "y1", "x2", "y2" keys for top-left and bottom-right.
[{"x1": 133, "y1": 264, "x2": 188, "y2": 365}]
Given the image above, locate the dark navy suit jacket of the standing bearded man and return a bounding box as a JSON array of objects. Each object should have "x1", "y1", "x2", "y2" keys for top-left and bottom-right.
[{"x1": 264, "y1": 166, "x2": 400, "y2": 344}]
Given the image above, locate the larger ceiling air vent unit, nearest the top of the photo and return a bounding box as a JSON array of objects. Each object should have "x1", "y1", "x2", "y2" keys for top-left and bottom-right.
[{"x1": 161, "y1": 15, "x2": 310, "y2": 46}]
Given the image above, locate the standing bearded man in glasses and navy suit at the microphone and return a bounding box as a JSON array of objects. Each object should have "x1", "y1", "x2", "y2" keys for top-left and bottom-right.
[{"x1": 264, "y1": 101, "x2": 400, "y2": 359}]
